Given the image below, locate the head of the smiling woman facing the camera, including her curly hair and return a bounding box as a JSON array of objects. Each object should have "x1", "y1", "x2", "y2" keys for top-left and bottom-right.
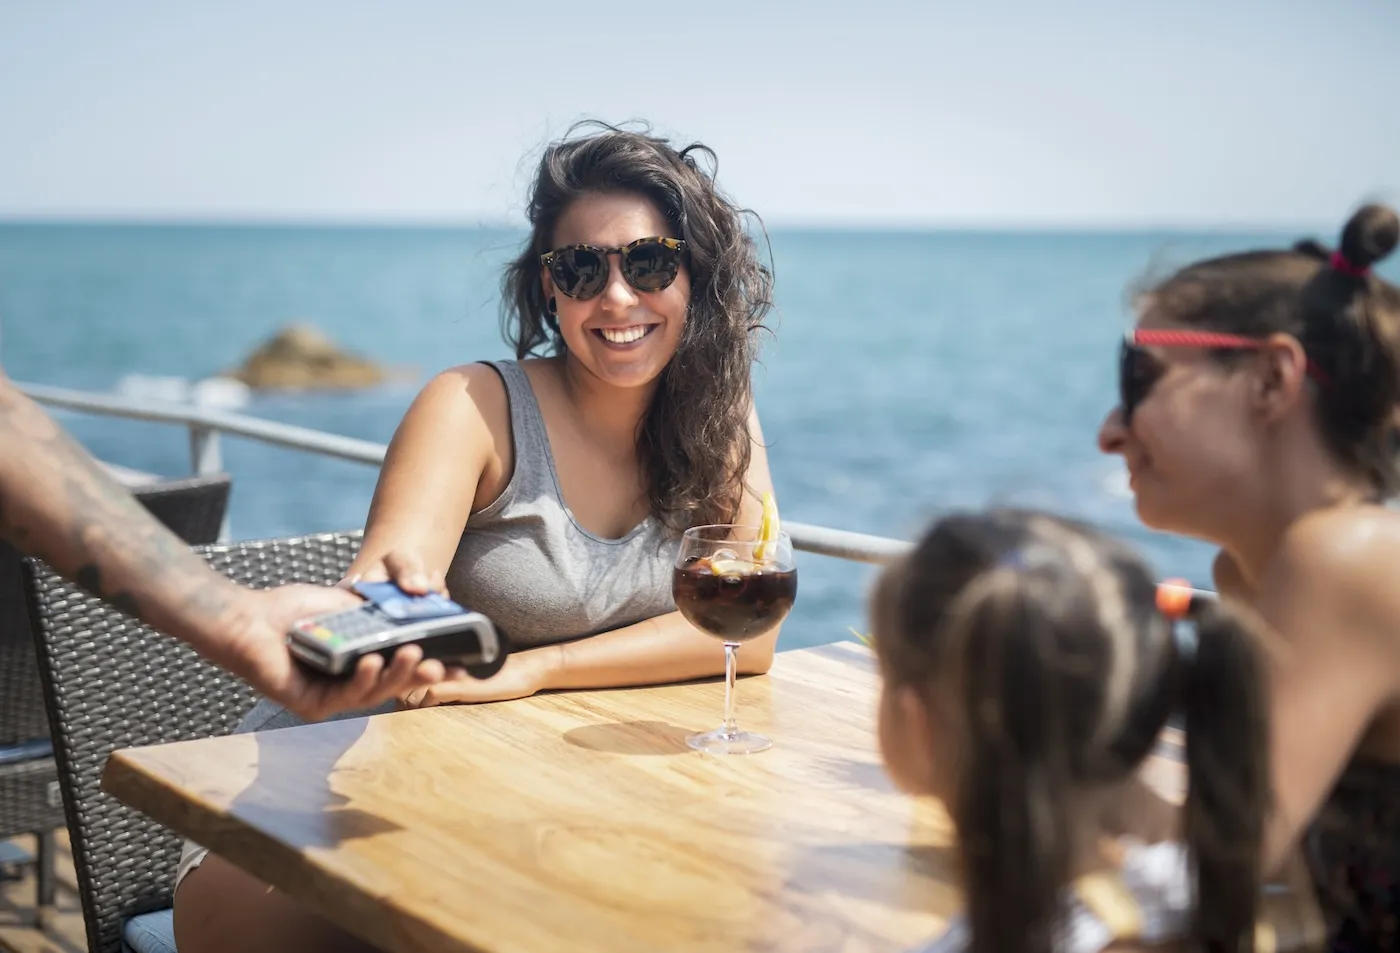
[{"x1": 503, "y1": 124, "x2": 771, "y2": 530}]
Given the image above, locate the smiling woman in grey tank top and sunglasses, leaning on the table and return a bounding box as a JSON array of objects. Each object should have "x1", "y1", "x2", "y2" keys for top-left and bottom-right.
[{"x1": 174, "y1": 127, "x2": 777, "y2": 953}]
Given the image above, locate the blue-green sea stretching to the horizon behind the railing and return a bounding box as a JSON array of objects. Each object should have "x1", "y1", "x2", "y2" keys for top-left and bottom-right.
[{"x1": 8, "y1": 223, "x2": 1400, "y2": 648}]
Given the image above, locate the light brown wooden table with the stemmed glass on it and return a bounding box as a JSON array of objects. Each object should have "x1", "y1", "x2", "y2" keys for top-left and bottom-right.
[{"x1": 104, "y1": 644, "x2": 959, "y2": 953}]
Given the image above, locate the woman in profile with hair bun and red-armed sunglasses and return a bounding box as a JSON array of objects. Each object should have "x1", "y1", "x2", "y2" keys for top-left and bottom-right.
[{"x1": 1099, "y1": 204, "x2": 1400, "y2": 950}]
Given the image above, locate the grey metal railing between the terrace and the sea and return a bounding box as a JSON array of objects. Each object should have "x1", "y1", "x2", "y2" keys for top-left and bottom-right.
[{"x1": 27, "y1": 383, "x2": 910, "y2": 564}]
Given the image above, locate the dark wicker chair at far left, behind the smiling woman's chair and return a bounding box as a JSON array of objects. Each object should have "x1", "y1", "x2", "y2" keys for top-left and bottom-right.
[{"x1": 0, "y1": 474, "x2": 230, "y2": 915}]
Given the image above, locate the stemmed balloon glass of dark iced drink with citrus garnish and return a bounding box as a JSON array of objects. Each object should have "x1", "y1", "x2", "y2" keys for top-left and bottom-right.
[{"x1": 671, "y1": 523, "x2": 797, "y2": 754}]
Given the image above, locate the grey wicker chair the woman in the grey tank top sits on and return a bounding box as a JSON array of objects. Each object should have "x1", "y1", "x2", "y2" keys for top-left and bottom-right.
[{"x1": 25, "y1": 532, "x2": 361, "y2": 953}]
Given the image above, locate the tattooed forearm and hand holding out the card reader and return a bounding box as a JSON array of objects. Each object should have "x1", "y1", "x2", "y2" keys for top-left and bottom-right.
[{"x1": 0, "y1": 372, "x2": 442, "y2": 718}]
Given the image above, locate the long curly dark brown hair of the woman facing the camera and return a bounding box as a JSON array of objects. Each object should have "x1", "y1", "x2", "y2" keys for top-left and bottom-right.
[{"x1": 501, "y1": 123, "x2": 773, "y2": 533}]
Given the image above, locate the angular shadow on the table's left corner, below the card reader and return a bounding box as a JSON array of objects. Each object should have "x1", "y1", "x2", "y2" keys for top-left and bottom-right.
[{"x1": 228, "y1": 718, "x2": 400, "y2": 848}]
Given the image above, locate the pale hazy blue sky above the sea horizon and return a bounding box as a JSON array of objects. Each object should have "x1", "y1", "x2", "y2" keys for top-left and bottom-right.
[{"x1": 0, "y1": 0, "x2": 1400, "y2": 228}]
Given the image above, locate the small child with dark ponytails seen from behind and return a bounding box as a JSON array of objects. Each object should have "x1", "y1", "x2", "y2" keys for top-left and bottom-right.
[{"x1": 872, "y1": 511, "x2": 1270, "y2": 953}]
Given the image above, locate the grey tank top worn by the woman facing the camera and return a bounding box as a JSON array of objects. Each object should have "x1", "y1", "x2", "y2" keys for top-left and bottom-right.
[{"x1": 447, "y1": 361, "x2": 679, "y2": 648}]
